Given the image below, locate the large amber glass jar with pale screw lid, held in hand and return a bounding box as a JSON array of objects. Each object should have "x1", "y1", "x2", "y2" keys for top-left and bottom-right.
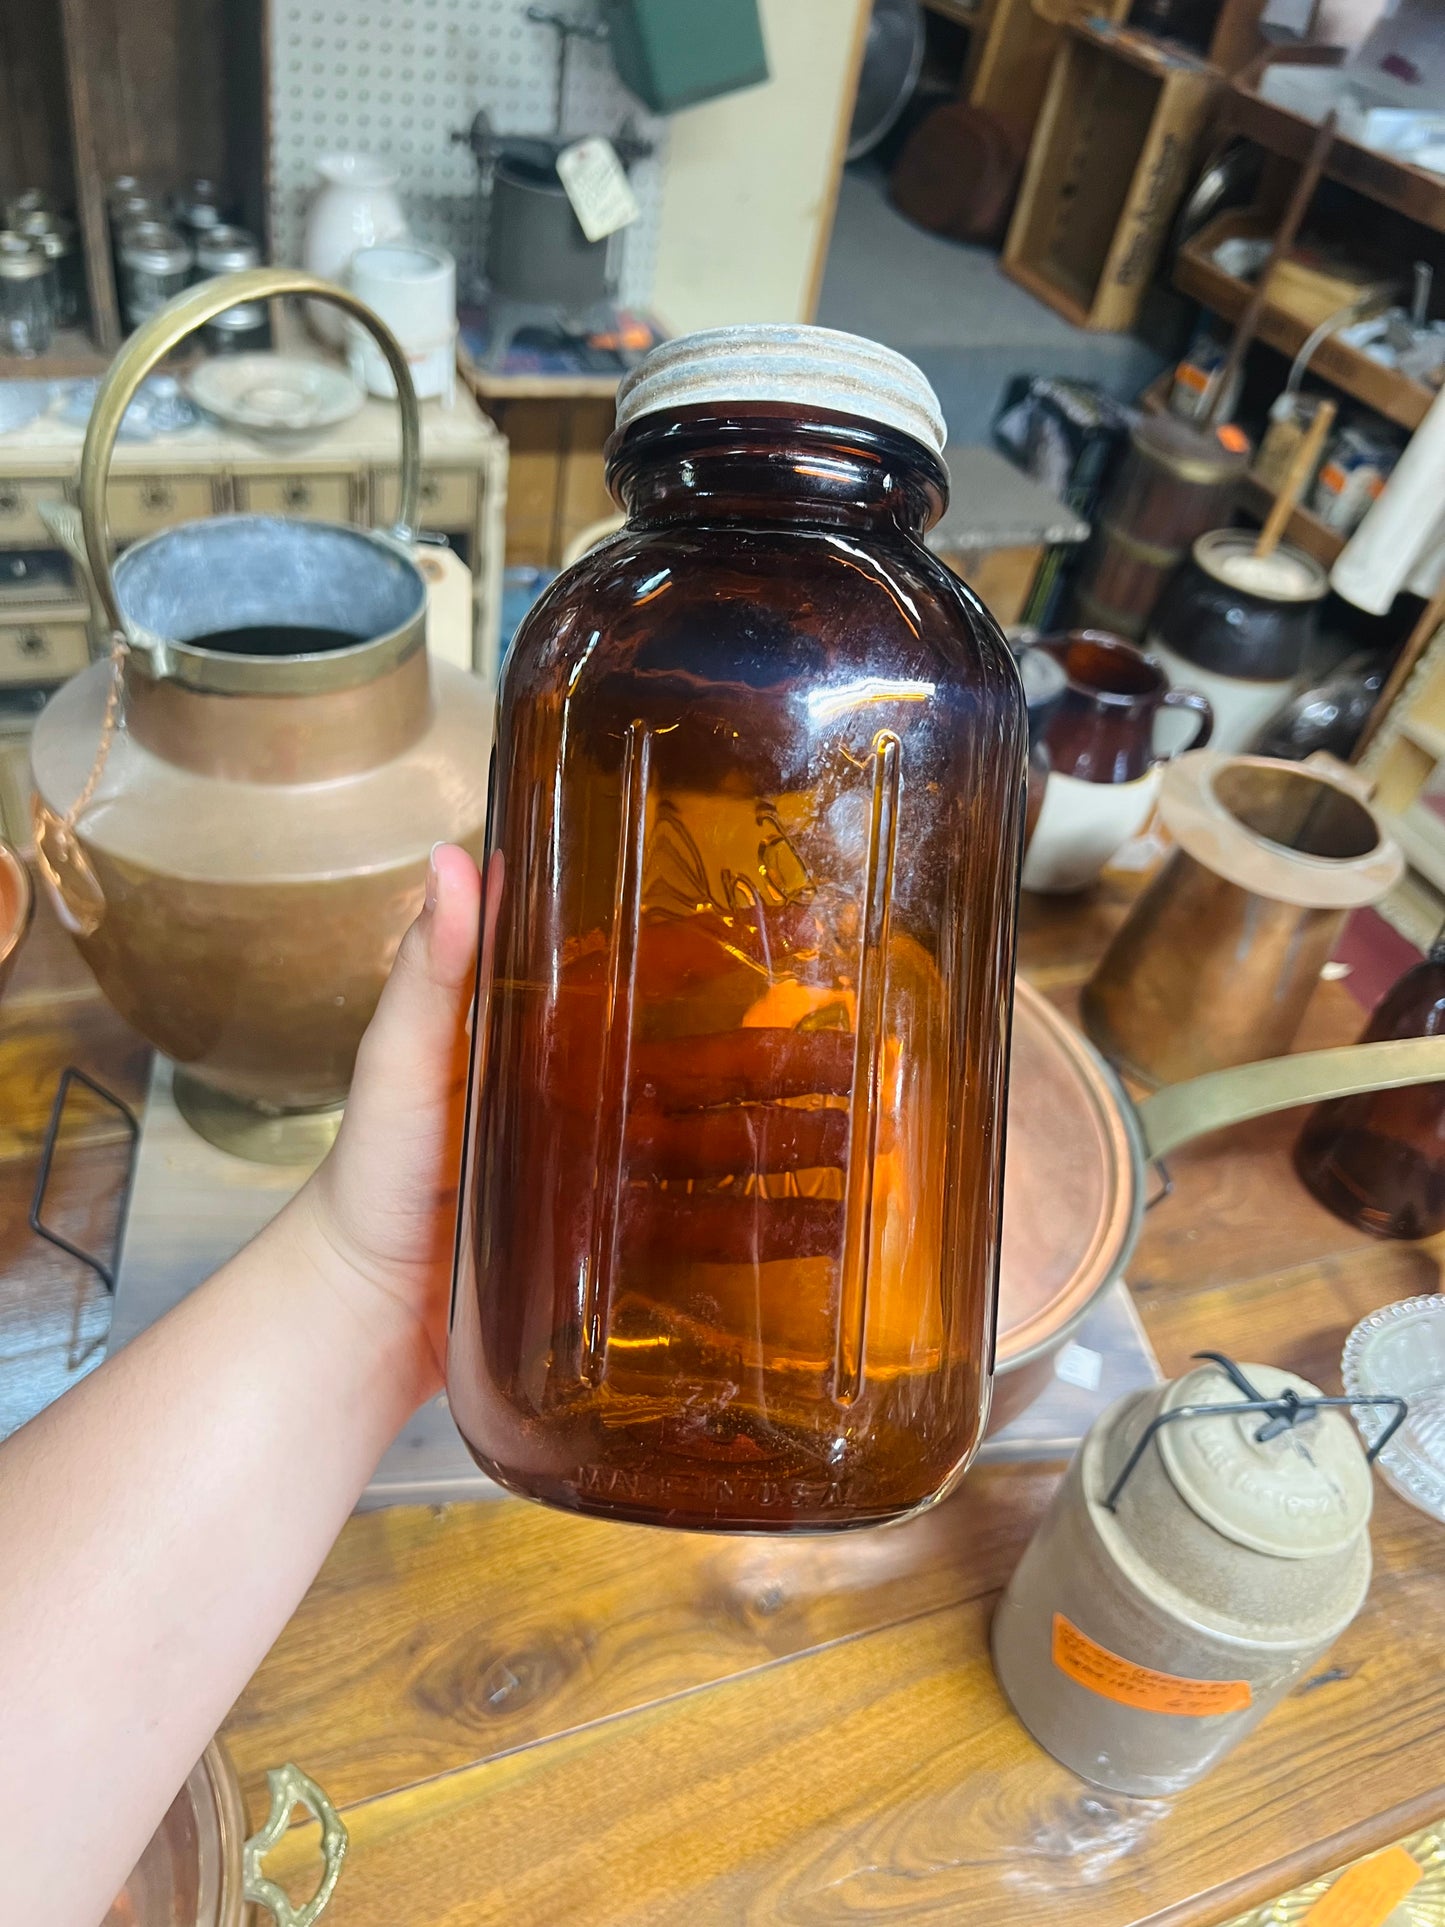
[{"x1": 449, "y1": 328, "x2": 1027, "y2": 1530}]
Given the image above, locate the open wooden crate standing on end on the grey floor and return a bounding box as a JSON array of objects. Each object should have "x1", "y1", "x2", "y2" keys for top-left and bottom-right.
[{"x1": 1004, "y1": 21, "x2": 1220, "y2": 330}]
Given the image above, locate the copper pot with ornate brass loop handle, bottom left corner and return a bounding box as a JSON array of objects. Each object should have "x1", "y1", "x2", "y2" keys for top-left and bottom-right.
[{"x1": 100, "y1": 1740, "x2": 347, "y2": 1927}]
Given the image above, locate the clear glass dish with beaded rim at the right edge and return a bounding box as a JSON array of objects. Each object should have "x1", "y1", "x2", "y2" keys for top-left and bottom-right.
[{"x1": 1339, "y1": 1295, "x2": 1445, "y2": 1520}]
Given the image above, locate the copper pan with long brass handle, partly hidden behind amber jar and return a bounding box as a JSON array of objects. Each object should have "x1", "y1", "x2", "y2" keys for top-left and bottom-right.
[{"x1": 988, "y1": 983, "x2": 1445, "y2": 1432}]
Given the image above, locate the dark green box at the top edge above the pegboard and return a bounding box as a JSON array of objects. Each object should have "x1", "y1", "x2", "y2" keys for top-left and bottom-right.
[{"x1": 603, "y1": 0, "x2": 769, "y2": 114}]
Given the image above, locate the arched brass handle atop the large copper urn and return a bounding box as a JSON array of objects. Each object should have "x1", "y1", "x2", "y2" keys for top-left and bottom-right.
[{"x1": 81, "y1": 268, "x2": 422, "y2": 636}]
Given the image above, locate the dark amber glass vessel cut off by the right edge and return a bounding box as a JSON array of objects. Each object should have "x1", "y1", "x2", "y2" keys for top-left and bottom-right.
[{"x1": 1295, "y1": 931, "x2": 1445, "y2": 1237}]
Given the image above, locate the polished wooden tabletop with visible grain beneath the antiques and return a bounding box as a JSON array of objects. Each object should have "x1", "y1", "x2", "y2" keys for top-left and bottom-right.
[{"x1": 0, "y1": 890, "x2": 1445, "y2": 1927}]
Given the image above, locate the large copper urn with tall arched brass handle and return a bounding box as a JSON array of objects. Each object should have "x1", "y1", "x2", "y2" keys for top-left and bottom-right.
[{"x1": 31, "y1": 268, "x2": 491, "y2": 1162}]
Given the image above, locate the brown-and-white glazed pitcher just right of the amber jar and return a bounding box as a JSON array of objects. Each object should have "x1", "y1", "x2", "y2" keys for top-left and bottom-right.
[{"x1": 1023, "y1": 628, "x2": 1214, "y2": 892}]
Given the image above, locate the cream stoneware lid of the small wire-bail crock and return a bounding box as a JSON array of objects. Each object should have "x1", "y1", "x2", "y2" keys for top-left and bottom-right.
[{"x1": 1158, "y1": 1364, "x2": 1374, "y2": 1559}]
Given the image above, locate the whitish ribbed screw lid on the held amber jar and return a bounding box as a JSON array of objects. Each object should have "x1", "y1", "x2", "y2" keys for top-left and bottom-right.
[{"x1": 617, "y1": 322, "x2": 948, "y2": 457}]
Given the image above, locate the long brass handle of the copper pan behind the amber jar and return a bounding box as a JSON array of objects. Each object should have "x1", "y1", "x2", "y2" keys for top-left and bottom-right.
[{"x1": 1137, "y1": 1037, "x2": 1445, "y2": 1158}]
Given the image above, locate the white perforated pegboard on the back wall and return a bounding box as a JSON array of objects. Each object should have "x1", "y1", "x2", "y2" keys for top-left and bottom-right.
[{"x1": 270, "y1": 0, "x2": 667, "y2": 308}]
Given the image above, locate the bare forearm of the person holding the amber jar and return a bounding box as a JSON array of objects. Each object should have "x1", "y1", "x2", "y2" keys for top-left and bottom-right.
[{"x1": 0, "y1": 1193, "x2": 435, "y2": 1927}]
